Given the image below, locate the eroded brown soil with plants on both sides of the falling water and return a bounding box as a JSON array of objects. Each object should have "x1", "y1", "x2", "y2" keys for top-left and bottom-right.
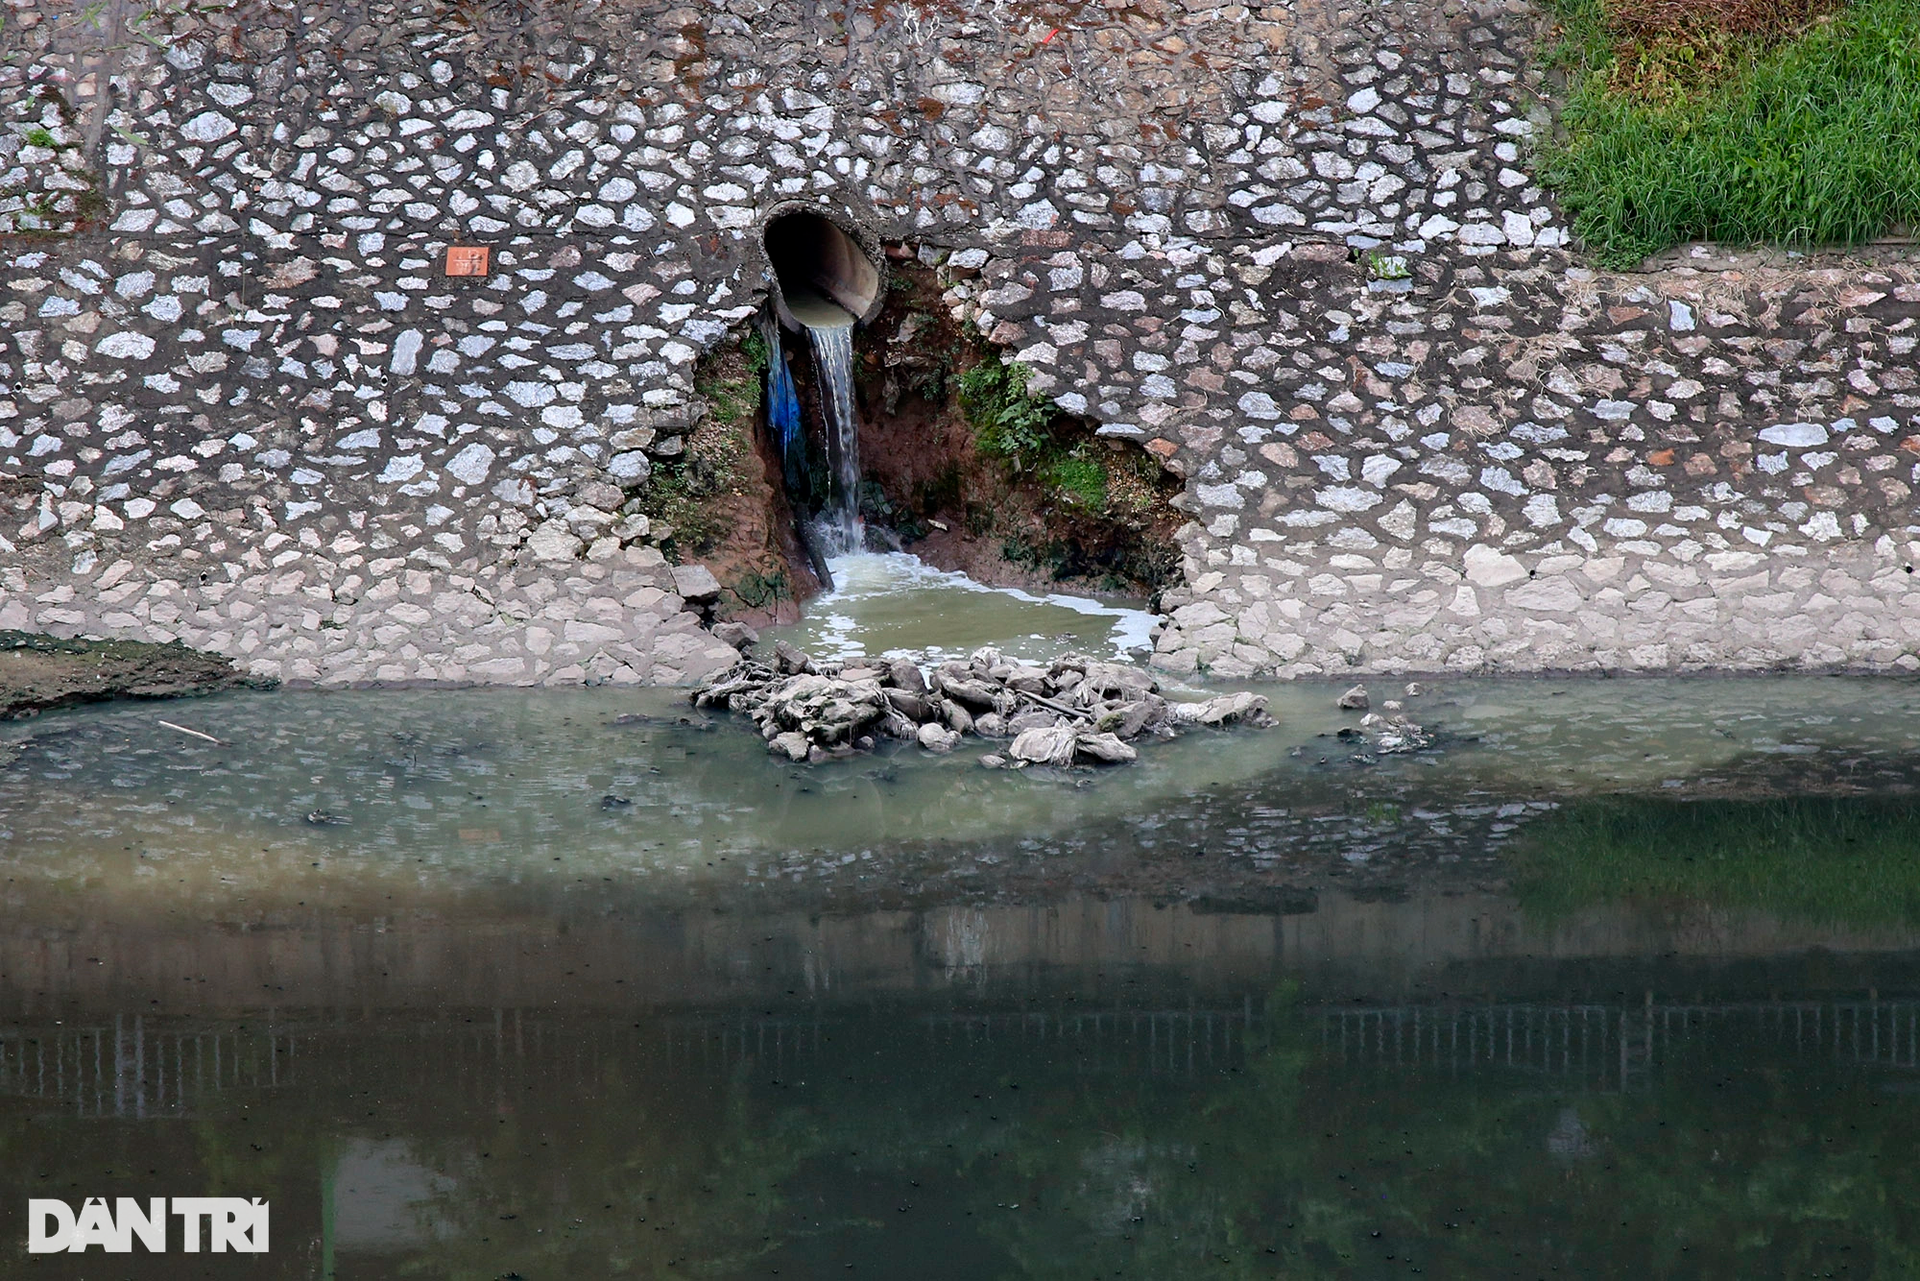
[{"x1": 645, "y1": 247, "x2": 1187, "y2": 624}]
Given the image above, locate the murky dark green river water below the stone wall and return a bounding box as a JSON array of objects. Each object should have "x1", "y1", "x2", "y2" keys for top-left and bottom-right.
[{"x1": 0, "y1": 678, "x2": 1920, "y2": 1279}]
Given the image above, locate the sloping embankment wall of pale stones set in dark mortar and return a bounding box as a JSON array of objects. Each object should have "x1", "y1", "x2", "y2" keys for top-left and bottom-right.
[{"x1": 0, "y1": 0, "x2": 1920, "y2": 684}]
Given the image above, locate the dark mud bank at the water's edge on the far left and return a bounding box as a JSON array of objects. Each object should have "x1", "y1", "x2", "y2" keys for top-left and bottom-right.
[{"x1": 0, "y1": 632, "x2": 257, "y2": 720}]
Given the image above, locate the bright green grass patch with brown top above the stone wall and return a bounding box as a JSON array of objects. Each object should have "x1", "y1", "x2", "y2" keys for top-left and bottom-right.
[{"x1": 1540, "y1": 0, "x2": 1920, "y2": 267}]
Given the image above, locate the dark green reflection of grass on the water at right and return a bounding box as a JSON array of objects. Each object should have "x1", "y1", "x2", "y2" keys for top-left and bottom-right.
[{"x1": 1511, "y1": 797, "x2": 1920, "y2": 926}]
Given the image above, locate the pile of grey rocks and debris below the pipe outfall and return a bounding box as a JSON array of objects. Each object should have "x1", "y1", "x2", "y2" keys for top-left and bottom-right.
[{"x1": 693, "y1": 641, "x2": 1273, "y2": 768}]
